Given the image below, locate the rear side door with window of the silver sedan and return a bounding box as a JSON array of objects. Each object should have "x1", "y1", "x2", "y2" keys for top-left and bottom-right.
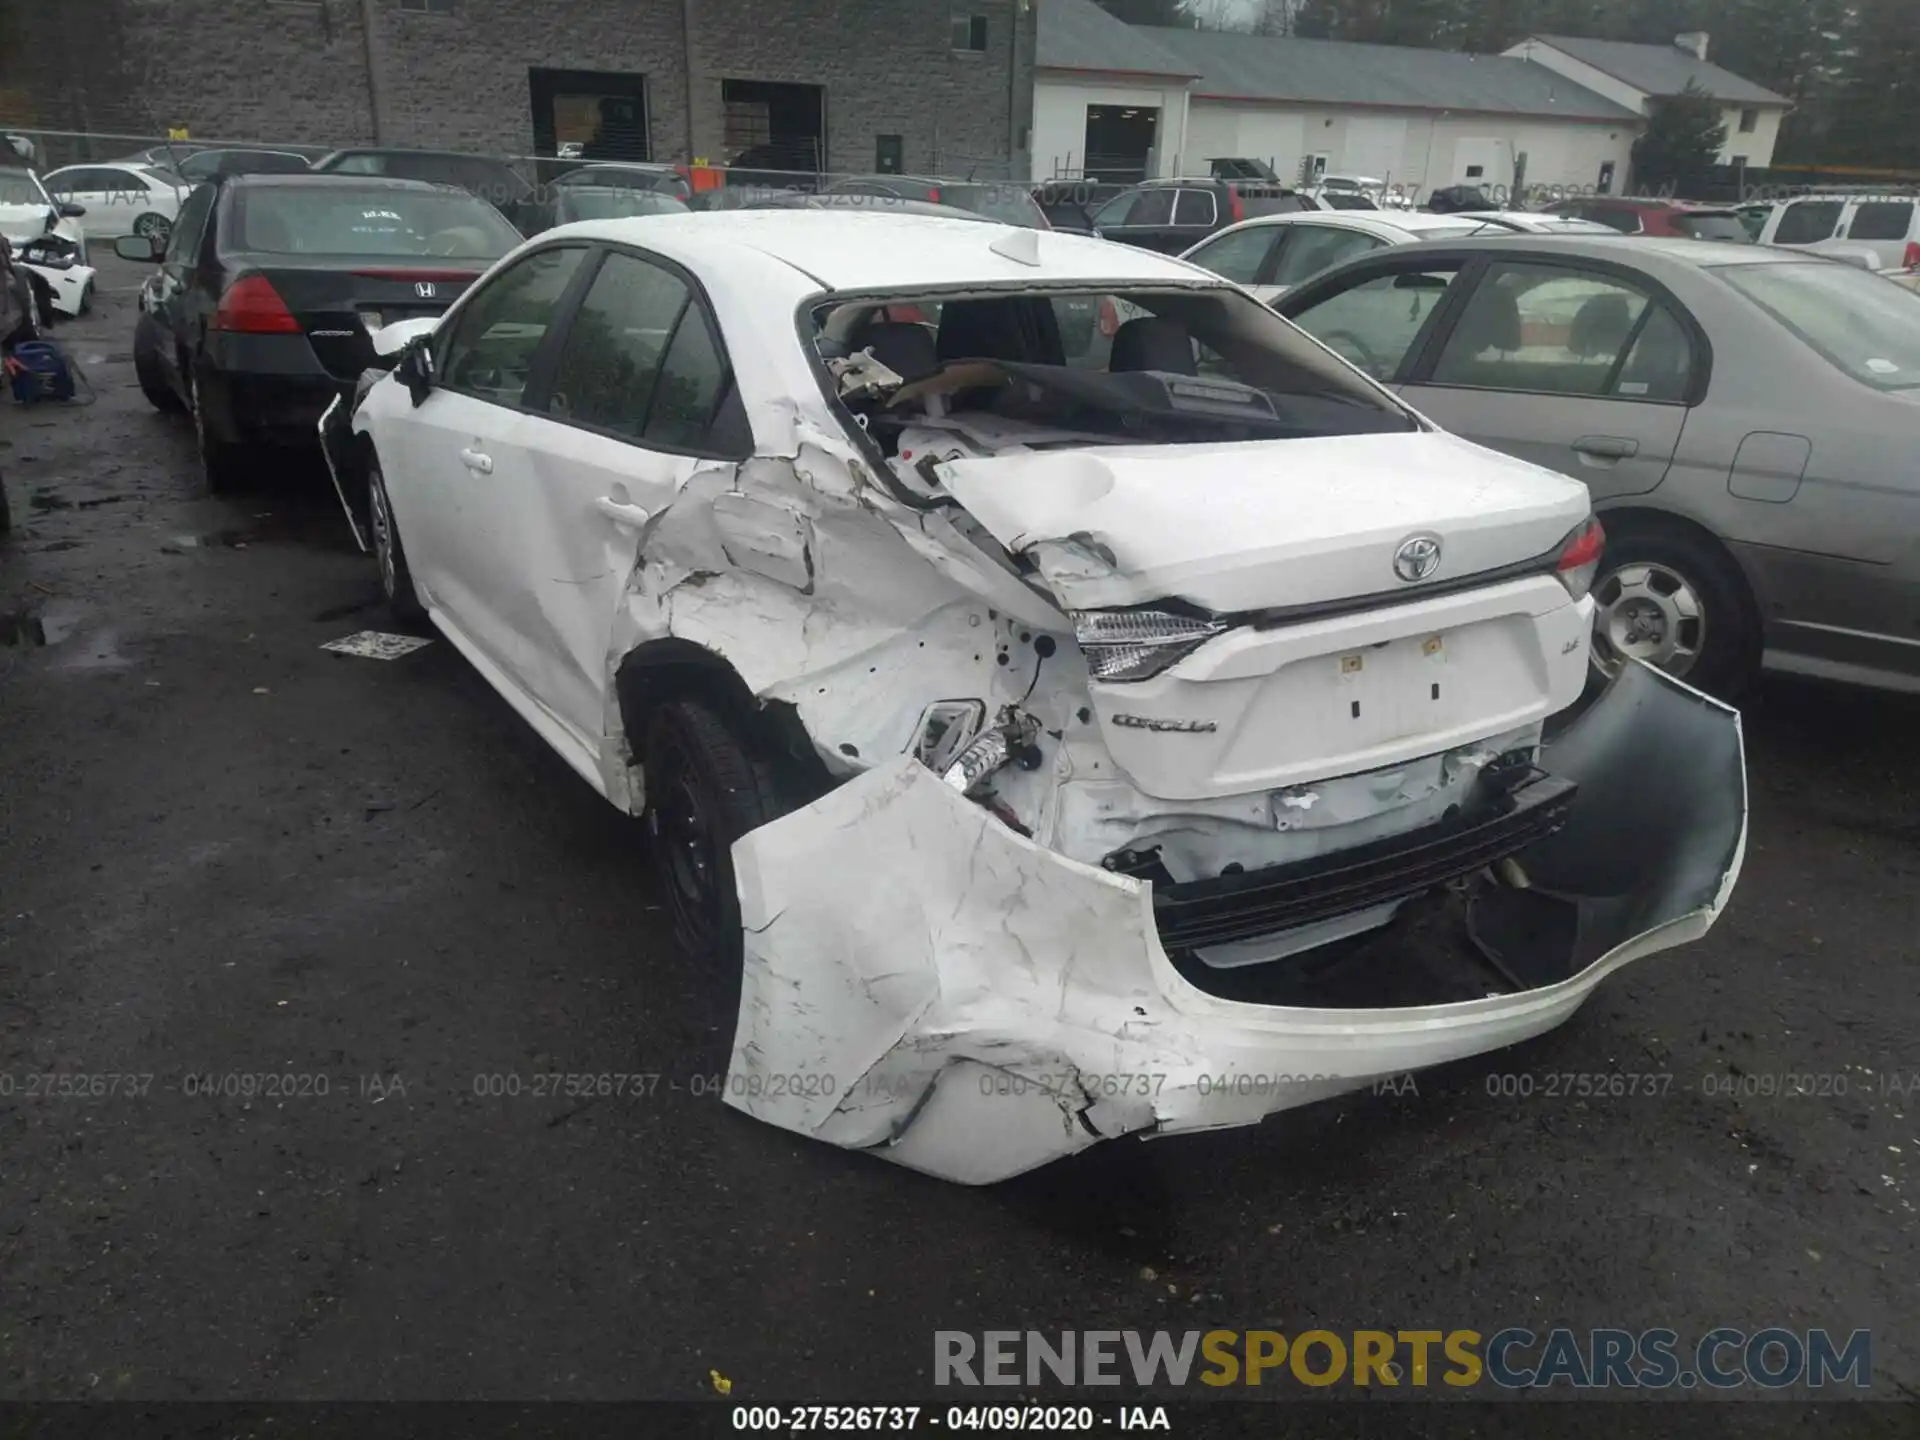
[{"x1": 1402, "y1": 257, "x2": 1705, "y2": 501}]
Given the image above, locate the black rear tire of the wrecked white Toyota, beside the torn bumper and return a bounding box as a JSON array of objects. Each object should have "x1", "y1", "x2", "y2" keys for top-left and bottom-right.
[{"x1": 645, "y1": 699, "x2": 781, "y2": 975}]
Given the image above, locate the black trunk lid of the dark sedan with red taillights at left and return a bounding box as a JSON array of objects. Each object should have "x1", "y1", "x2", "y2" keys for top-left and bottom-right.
[{"x1": 250, "y1": 255, "x2": 490, "y2": 380}]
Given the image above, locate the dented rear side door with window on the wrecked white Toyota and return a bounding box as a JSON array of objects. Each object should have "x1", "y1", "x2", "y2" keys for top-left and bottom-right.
[{"x1": 501, "y1": 250, "x2": 752, "y2": 768}]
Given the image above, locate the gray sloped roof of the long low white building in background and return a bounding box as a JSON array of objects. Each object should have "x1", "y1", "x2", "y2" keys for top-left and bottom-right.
[{"x1": 1136, "y1": 27, "x2": 1640, "y2": 123}]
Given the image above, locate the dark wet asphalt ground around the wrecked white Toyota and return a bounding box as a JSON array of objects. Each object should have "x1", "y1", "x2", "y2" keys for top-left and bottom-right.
[{"x1": 0, "y1": 257, "x2": 1920, "y2": 1434}]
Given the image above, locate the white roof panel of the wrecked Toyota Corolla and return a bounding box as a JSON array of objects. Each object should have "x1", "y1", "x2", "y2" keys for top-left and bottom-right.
[{"x1": 541, "y1": 207, "x2": 1225, "y2": 292}]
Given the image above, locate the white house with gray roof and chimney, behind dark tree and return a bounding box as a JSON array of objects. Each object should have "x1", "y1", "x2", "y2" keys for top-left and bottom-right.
[{"x1": 1507, "y1": 31, "x2": 1793, "y2": 171}]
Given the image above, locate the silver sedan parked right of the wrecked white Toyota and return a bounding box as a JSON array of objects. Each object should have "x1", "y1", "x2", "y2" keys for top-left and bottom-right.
[{"x1": 1275, "y1": 234, "x2": 1920, "y2": 693}]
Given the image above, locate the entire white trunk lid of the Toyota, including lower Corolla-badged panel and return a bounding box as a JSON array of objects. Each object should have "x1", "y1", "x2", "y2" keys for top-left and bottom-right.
[{"x1": 939, "y1": 432, "x2": 1592, "y2": 806}]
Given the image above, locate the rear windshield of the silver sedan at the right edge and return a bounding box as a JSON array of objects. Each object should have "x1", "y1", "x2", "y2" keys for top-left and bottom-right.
[{"x1": 1715, "y1": 261, "x2": 1920, "y2": 390}]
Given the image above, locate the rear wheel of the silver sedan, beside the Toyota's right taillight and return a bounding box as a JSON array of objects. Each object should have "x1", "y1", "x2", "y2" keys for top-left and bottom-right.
[{"x1": 1592, "y1": 516, "x2": 1761, "y2": 699}]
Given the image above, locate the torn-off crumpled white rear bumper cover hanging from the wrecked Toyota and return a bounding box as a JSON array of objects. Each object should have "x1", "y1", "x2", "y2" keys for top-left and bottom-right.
[{"x1": 728, "y1": 664, "x2": 1747, "y2": 1185}]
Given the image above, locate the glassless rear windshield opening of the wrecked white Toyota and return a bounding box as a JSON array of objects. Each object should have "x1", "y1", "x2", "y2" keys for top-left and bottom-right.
[{"x1": 812, "y1": 286, "x2": 1419, "y2": 455}]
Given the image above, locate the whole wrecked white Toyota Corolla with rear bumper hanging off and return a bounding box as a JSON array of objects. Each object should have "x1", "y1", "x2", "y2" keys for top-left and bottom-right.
[{"x1": 334, "y1": 209, "x2": 1745, "y2": 1183}]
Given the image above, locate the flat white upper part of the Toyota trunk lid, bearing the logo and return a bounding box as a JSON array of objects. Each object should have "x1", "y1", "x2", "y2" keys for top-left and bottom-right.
[{"x1": 939, "y1": 422, "x2": 1590, "y2": 614}]
